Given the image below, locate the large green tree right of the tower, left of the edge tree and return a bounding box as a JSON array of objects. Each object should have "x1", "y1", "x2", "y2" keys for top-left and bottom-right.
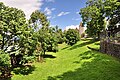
[{"x1": 80, "y1": 0, "x2": 105, "y2": 39}]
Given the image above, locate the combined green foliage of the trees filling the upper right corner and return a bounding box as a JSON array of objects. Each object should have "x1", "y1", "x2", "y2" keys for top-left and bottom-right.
[{"x1": 80, "y1": 0, "x2": 120, "y2": 38}]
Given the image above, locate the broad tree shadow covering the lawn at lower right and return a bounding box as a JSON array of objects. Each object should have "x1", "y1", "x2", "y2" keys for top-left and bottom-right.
[{"x1": 48, "y1": 51, "x2": 120, "y2": 80}]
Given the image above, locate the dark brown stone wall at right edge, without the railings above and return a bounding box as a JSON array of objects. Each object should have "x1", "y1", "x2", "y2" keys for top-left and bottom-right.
[{"x1": 100, "y1": 41, "x2": 120, "y2": 58}]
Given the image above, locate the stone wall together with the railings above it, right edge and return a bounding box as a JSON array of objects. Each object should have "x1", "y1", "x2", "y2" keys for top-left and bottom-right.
[{"x1": 100, "y1": 31, "x2": 120, "y2": 58}]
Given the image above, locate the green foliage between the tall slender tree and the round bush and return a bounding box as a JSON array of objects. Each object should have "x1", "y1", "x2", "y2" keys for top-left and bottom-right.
[{"x1": 39, "y1": 28, "x2": 57, "y2": 52}]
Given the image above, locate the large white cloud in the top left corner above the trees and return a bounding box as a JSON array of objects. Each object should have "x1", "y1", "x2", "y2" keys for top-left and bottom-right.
[{"x1": 0, "y1": 0, "x2": 43, "y2": 19}]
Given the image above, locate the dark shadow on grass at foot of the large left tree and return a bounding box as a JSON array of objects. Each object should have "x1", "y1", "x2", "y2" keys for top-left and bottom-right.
[{"x1": 13, "y1": 65, "x2": 35, "y2": 75}]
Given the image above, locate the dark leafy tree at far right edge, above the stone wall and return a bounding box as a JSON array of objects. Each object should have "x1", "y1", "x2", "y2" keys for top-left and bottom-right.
[{"x1": 104, "y1": 0, "x2": 120, "y2": 36}]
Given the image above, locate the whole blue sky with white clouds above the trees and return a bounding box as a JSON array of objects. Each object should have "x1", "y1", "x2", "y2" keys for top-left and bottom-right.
[{"x1": 0, "y1": 0, "x2": 87, "y2": 30}]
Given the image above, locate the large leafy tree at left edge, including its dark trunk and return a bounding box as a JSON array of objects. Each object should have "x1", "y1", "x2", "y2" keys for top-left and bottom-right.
[{"x1": 0, "y1": 3, "x2": 32, "y2": 67}]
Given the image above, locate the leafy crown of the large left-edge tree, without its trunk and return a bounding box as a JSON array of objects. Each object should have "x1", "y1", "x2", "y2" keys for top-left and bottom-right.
[{"x1": 0, "y1": 3, "x2": 27, "y2": 51}]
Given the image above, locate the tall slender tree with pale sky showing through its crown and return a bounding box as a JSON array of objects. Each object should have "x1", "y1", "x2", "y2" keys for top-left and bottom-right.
[{"x1": 29, "y1": 10, "x2": 49, "y2": 55}]
